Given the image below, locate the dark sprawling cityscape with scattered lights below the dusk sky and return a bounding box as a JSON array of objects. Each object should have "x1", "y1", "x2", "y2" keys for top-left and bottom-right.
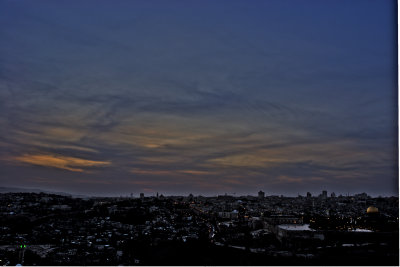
[{"x1": 0, "y1": 192, "x2": 399, "y2": 265}]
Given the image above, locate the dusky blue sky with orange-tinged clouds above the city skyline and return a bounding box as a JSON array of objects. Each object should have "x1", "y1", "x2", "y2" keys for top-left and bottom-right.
[{"x1": 0, "y1": 0, "x2": 398, "y2": 196}]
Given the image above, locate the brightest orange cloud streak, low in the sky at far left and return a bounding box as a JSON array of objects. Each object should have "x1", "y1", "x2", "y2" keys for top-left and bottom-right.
[{"x1": 14, "y1": 154, "x2": 110, "y2": 172}]
